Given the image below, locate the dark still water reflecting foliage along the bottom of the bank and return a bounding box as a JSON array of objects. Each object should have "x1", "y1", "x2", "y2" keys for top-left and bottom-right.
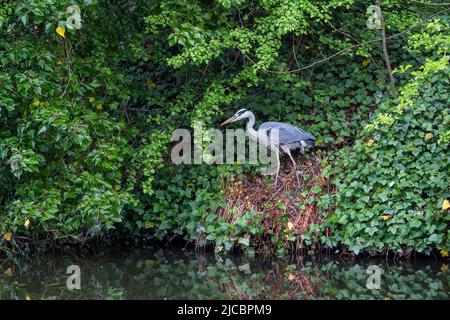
[{"x1": 0, "y1": 248, "x2": 450, "y2": 300}]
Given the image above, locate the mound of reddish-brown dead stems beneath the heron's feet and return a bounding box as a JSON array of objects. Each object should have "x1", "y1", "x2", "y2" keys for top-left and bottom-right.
[{"x1": 218, "y1": 155, "x2": 334, "y2": 250}]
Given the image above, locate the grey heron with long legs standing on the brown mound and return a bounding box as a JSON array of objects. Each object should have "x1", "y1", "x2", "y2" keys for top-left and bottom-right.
[{"x1": 220, "y1": 109, "x2": 316, "y2": 185}]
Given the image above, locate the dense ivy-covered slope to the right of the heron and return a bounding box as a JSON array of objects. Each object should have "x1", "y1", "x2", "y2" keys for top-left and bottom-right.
[{"x1": 324, "y1": 20, "x2": 450, "y2": 253}]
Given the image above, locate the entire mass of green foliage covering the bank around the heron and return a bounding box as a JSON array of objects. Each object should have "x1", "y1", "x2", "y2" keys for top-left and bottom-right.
[{"x1": 0, "y1": 0, "x2": 450, "y2": 252}]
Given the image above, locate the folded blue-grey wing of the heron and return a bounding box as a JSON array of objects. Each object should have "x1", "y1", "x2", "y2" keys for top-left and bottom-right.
[{"x1": 258, "y1": 122, "x2": 316, "y2": 145}]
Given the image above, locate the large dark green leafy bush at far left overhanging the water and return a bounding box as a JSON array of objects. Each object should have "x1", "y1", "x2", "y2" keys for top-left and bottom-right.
[{"x1": 0, "y1": 1, "x2": 158, "y2": 242}]
